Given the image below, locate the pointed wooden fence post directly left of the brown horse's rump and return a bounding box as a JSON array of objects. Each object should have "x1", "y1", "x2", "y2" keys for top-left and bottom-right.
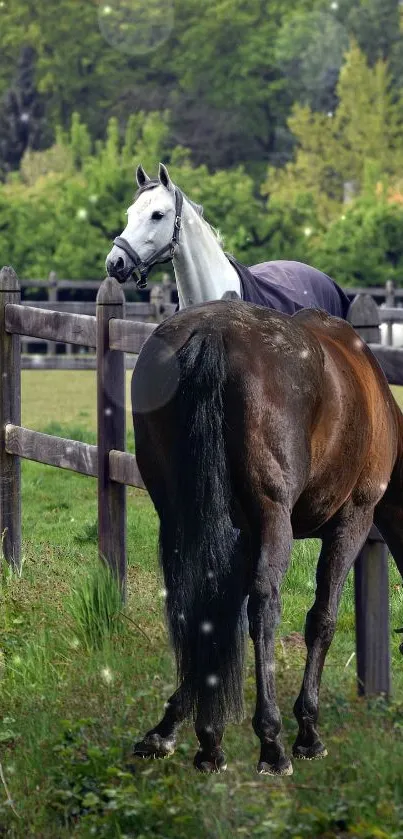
[{"x1": 96, "y1": 277, "x2": 126, "y2": 598}]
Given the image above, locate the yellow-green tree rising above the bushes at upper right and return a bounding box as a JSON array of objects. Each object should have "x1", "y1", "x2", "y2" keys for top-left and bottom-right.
[{"x1": 264, "y1": 43, "x2": 403, "y2": 224}]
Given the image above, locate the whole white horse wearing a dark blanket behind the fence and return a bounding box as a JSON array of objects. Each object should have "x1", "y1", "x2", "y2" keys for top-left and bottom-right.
[{"x1": 106, "y1": 163, "x2": 349, "y2": 318}]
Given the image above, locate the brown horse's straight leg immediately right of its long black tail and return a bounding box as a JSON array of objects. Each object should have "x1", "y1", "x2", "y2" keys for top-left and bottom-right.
[{"x1": 248, "y1": 501, "x2": 292, "y2": 775}]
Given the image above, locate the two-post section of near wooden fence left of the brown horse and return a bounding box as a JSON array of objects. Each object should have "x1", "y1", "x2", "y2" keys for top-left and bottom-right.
[{"x1": 0, "y1": 268, "x2": 152, "y2": 592}]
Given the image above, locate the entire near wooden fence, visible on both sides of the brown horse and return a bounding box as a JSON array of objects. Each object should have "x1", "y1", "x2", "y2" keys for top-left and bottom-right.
[{"x1": 0, "y1": 268, "x2": 403, "y2": 694}]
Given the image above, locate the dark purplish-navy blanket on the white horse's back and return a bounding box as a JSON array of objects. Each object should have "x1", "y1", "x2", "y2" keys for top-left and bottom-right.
[{"x1": 226, "y1": 254, "x2": 350, "y2": 319}]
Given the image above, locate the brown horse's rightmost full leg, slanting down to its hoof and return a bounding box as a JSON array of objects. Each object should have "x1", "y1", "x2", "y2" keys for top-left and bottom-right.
[{"x1": 293, "y1": 502, "x2": 373, "y2": 760}]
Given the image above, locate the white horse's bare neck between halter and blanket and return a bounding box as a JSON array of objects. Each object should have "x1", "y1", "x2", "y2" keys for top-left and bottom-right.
[{"x1": 173, "y1": 200, "x2": 241, "y2": 309}]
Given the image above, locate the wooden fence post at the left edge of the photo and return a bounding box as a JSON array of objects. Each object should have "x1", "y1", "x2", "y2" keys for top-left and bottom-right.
[{"x1": 0, "y1": 268, "x2": 21, "y2": 571}]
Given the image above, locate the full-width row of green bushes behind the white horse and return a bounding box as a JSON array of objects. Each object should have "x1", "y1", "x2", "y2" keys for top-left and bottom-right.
[{"x1": 0, "y1": 106, "x2": 403, "y2": 285}]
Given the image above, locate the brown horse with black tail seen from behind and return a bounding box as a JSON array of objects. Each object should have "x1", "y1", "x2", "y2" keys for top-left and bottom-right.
[{"x1": 132, "y1": 301, "x2": 403, "y2": 775}]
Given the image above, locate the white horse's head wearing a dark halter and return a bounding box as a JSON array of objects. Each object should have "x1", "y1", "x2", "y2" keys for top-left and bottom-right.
[{"x1": 106, "y1": 163, "x2": 190, "y2": 288}]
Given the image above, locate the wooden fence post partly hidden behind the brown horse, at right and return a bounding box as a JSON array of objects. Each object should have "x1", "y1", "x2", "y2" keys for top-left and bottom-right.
[{"x1": 347, "y1": 294, "x2": 391, "y2": 696}]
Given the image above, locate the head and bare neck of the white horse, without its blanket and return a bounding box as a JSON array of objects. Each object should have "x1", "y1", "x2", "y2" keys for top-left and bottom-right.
[{"x1": 106, "y1": 163, "x2": 242, "y2": 309}]
